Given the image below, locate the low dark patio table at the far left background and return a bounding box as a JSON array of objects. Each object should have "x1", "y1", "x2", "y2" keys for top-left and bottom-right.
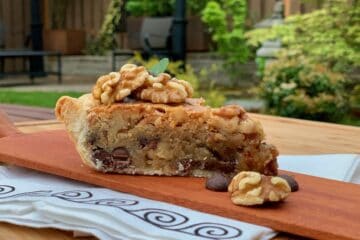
[{"x1": 0, "y1": 49, "x2": 62, "y2": 84}]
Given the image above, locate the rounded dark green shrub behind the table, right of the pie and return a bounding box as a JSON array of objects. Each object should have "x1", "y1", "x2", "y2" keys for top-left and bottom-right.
[{"x1": 258, "y1": 56, "x2": 348, "y2": 122}]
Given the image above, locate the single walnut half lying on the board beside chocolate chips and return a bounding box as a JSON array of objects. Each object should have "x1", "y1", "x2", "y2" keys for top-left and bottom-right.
[{"x1": 228, "y1": 171, "x2": 291, "y2": 206}]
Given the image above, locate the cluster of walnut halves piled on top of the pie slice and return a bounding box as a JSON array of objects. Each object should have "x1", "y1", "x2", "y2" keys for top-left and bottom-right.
[{"x1": 93, "y1": 64, "x2": 193, "y2": 105}]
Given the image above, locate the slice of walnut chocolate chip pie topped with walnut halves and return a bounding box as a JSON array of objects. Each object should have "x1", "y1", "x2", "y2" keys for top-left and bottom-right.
[{"x1": 55, "y1": 64, "x2": 278, "y2": 176}]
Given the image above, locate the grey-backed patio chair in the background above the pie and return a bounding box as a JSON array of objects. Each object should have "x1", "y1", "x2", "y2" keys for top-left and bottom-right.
[{"x1": 112, "y1": 17, "x2": 173, "y2": 71}]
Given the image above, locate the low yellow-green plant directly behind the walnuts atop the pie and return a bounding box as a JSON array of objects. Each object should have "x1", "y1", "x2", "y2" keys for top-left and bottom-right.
[{"x1": 129, "y1": 53, "x2": 226, "y2": 107}]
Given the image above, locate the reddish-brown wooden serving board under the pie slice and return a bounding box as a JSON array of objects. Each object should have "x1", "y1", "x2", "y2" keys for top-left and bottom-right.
[{"x1": 0, "y1": 129, "x2": 360, "y2": 240}]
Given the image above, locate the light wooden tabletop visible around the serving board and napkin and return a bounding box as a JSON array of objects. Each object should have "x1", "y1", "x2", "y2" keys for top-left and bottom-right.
[{"x1": 0, "y1": 114, "x2": 360, "y2": 240}]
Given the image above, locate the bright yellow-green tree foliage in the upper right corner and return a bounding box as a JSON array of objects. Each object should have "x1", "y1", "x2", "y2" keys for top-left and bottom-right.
[{"x1": 246, "y1": 0, "x2": 360, "y2": 72}]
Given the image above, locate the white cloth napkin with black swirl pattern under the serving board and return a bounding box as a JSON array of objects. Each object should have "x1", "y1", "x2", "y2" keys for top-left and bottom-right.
[{"x1": 0, "y1": 154, "x2": 360, "y2": 240}]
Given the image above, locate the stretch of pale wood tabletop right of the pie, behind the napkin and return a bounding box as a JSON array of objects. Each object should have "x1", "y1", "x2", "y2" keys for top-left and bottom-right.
[{"x1": 250, "y1": 114, "x2": 360, "y2": 154}]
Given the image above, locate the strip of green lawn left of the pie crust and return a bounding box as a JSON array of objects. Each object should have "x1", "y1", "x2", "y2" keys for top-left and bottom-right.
[{"x1": 0, "y1": 90, "x2": 83, "y2": 108}]
